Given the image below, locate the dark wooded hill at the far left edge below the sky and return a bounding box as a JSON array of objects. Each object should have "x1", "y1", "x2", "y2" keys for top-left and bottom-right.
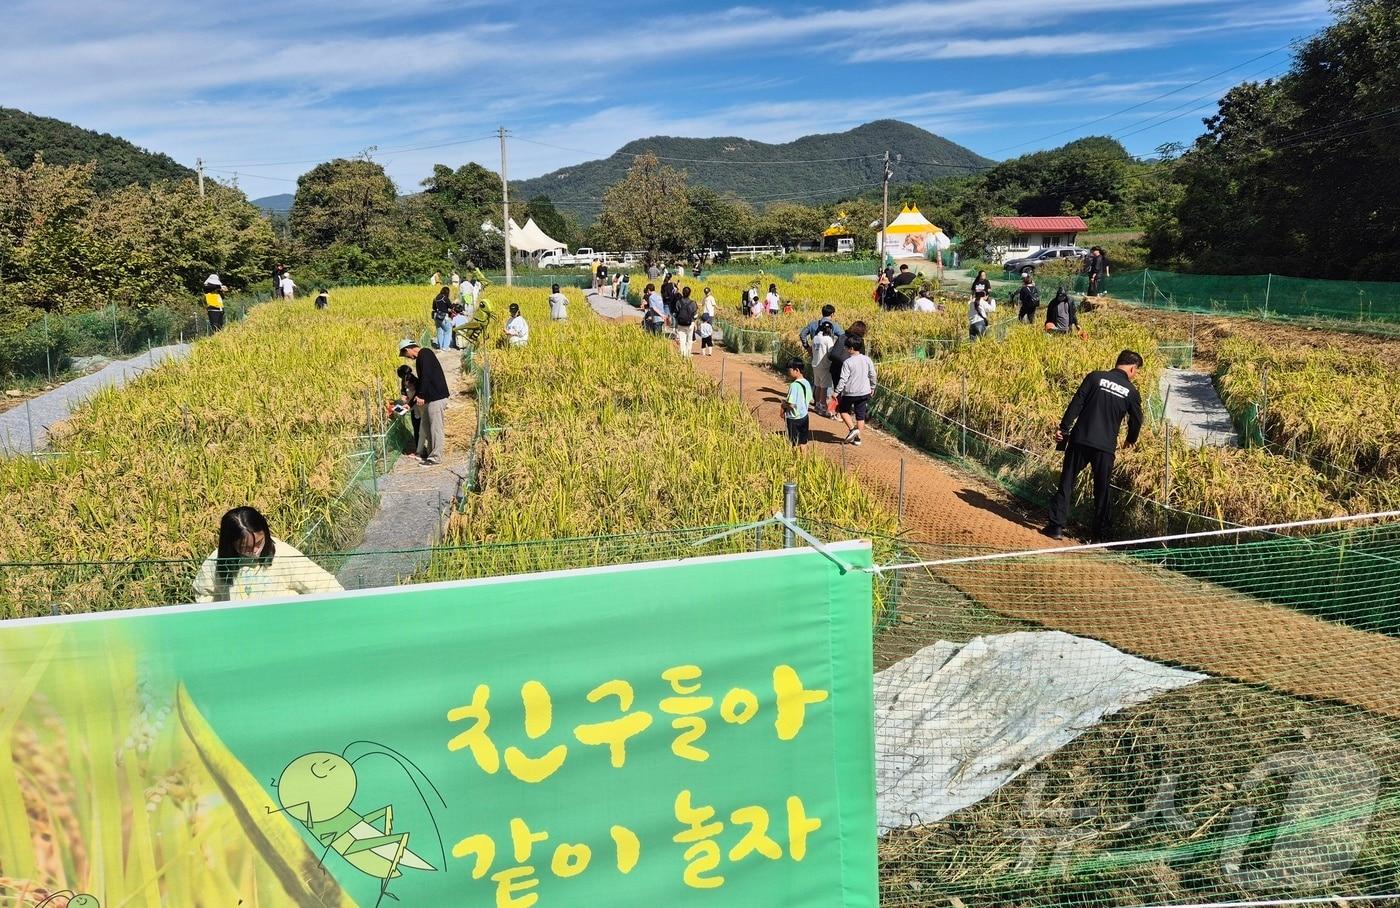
[{"x1": 0, "y1": 108, "x2": 195, "y2": 192}]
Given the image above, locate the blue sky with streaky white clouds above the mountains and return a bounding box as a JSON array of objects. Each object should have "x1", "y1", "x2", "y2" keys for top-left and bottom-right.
[{"x1": 0, "y1": 0, "x2": 1330, "y2": 197}]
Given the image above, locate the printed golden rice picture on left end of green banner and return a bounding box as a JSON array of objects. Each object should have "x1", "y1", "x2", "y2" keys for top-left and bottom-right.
[{"x1": 0, "y1": 625, "x2": 353, "y2": 908}]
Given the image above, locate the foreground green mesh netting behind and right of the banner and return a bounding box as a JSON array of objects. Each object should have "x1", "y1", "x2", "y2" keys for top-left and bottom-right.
[{"x1": 0, "y1": 522, "x2": 1400, "y2": 908}]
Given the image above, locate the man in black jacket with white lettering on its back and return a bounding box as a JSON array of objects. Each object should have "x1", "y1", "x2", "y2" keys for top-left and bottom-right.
[{"x1": 1044, "y1": 350, "x2": 1142, "y2": 541}]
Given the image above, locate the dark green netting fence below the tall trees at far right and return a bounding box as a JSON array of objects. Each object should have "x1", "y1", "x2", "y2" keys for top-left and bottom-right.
[{"x1": 1074, "y1": 270, "x2": 1400, "y2": 332}]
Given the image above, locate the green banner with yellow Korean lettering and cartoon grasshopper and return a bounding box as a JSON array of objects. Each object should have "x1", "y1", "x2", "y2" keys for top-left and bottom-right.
[{"x1": 0, "y1": 543, "x2": 876, "y2": 908}]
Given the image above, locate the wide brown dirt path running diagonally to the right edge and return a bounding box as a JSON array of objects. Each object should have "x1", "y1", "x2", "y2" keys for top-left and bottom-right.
[{"x1": 678, "y1": 350, "x2": 1400, "y2": 715}]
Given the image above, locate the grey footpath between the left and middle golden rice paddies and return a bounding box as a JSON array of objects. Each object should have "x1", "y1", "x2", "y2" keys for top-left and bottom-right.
[{"x1": 336, "y1": 350, "x2": 476, "y2": 589}]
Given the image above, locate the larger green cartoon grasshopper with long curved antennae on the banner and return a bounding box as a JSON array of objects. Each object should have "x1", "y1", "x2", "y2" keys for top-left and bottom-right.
[{"x1": 267, "y1": 742, "x2": 447, "y2": 907}]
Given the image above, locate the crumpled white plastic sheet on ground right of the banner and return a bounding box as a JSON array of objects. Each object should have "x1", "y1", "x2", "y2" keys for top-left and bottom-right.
[{"x1": 875, "y1": 631, "x2": 1207, "y2": 830}]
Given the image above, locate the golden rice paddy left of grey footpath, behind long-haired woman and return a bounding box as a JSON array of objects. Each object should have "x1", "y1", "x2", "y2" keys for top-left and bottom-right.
[{"x1": 0, "y1": 288, "x2": 431, "y2": 617}]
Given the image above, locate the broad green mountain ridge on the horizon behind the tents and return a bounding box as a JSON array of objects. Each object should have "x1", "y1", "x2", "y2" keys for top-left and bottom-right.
[{"x1": 511, "y1": 120, "x2": 993, "y2": 221}]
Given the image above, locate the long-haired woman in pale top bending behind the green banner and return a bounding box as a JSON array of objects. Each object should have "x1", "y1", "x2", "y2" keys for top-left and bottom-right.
[{"x1": 195, "y1": 506, "x2": 343, "y2": 602}]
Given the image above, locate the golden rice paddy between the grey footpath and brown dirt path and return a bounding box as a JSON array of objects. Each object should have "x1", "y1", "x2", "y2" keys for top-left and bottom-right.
[{"x1": 438, "y1": 291, "x2": 895, "y2": 575}]
